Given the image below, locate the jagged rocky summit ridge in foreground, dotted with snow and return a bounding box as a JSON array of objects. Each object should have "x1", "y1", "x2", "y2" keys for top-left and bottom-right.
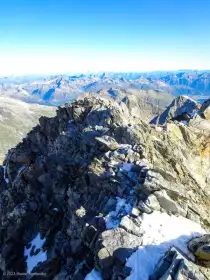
[{"x1": 0, "y1": 96, "x2": 210, "y2": 280}]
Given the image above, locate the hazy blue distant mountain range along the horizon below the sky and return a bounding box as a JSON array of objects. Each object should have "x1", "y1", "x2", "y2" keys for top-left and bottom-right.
[{"x1": 0, "y1": 71, "x2": 210, "y2": 107}]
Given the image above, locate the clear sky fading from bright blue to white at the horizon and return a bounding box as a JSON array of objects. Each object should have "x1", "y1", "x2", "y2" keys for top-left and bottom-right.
[{"x1": 0, "y1": 0, "x2": 210, "y2": 74}]
